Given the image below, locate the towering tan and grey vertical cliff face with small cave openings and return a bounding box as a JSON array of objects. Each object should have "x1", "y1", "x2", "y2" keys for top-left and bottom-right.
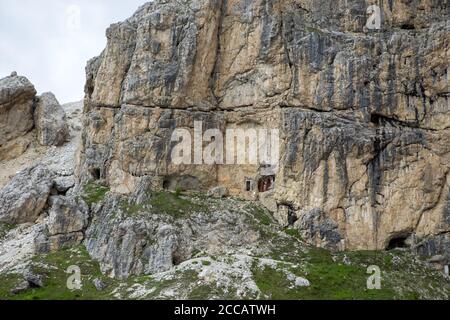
[{"x1": 78, "y1": 0, "x2": 450, "y2": 251}]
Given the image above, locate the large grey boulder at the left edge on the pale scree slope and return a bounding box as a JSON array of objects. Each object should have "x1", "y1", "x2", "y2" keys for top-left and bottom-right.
[{"x1": 0, "y1": 165, "x2": 53, "y2": 224}]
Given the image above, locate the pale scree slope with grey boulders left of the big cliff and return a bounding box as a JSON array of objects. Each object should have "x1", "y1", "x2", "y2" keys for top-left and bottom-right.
[{"x1": 0, "y1": 99, "x2": 83, "y2": 272}]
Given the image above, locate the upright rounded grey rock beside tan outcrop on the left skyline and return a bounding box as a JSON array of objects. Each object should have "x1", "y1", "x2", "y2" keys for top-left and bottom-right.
[{"x1": 34, "y1": 92, "x2": 69, "y2": 146}]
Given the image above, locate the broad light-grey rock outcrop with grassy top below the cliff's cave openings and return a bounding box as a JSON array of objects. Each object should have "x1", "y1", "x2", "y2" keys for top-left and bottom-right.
[{"x1": 85, "y1": 195, "x2": 260, "y2": 279}]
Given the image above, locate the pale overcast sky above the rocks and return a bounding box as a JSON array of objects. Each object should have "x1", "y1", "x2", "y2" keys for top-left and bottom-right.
[{"x1": 0, "y1": 0, "x2": 147, "y2": 103}]
